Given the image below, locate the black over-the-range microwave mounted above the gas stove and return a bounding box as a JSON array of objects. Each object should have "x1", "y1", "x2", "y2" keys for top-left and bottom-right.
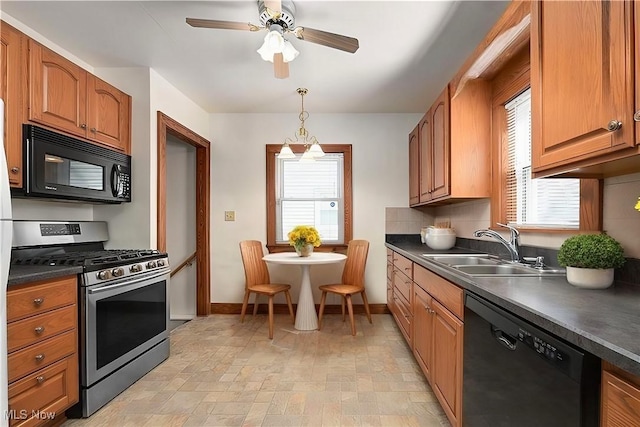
[{"x1": 14, "y1": 125, "x2": 131, "y2": 203}]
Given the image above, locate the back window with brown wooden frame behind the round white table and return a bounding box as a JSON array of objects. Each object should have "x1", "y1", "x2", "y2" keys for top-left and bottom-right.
[{"x1": 267, "y1": 144, "x2": 352, "y2": 252}]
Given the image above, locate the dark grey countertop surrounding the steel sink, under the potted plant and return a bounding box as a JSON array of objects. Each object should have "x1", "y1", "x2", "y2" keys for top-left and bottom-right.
[{"x1": 386, "y1": 242, "x2": 640, "y2": 375}]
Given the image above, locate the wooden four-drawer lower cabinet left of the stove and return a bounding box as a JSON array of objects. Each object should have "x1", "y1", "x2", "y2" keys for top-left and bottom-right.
[{"x1": 7, "y1": 276, "x2": 79, "y2": 427}]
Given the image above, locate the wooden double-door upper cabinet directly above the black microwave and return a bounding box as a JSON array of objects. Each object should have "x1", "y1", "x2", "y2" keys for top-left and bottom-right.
[{"x1": 27, "y1": 40, "x2": 131, "y2": 153}]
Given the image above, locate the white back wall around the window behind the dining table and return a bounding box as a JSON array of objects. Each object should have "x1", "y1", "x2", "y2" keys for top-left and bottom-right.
[{"x1": 211, "y1": 112, "x2": 420, "y2": 304}]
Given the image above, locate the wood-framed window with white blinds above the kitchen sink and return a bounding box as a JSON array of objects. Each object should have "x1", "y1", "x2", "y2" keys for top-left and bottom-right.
[{"x1": 491, "y1": 46, "x2": 602, "y2": 232}]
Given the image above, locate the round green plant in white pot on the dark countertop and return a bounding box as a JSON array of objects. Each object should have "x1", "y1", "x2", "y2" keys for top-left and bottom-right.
[{"x1": 558, "y1": 234, "x2": 625, "y2": 289}]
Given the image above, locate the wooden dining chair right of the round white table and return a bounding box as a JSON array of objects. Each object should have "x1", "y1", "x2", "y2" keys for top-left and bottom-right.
[{"x1": 318, "y1": 240, "x2": 373, "y2": 335}]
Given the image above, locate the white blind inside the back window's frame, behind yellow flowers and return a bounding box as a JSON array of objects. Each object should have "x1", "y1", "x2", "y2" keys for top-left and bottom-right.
[{"x1": 276, "y1": 153, "x2": 344, "y2": 244}]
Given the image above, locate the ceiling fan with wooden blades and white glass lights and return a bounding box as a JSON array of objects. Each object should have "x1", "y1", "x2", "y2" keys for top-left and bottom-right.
[{"x1": 187, "y1": 0, "x2": 359, "y2": 79}]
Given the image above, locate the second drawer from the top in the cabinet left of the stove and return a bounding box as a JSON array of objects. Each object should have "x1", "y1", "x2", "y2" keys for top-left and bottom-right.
[{"x1": 7, "y1": 305, "x2": 78, "y2": 353}]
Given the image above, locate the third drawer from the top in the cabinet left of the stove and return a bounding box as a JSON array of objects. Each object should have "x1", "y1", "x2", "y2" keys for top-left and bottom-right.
[{"x1": 8, "y1": 331, "x2": 77, "y2": 382}]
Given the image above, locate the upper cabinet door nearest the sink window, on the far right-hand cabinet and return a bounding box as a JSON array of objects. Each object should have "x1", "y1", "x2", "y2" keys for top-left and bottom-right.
[{"x1": 430, "y1": 86, "x2": 450, "y2": 199}]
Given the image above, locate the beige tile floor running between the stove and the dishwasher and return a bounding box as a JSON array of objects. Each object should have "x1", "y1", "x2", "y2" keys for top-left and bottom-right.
[{"x1": 63, "y1": 314, "x2": 449, "y2": 427}]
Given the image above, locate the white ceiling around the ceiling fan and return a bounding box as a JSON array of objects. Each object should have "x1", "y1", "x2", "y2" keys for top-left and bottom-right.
[{"x1": 0, "y1": 0, "x2": 509, "y2": 113}]
